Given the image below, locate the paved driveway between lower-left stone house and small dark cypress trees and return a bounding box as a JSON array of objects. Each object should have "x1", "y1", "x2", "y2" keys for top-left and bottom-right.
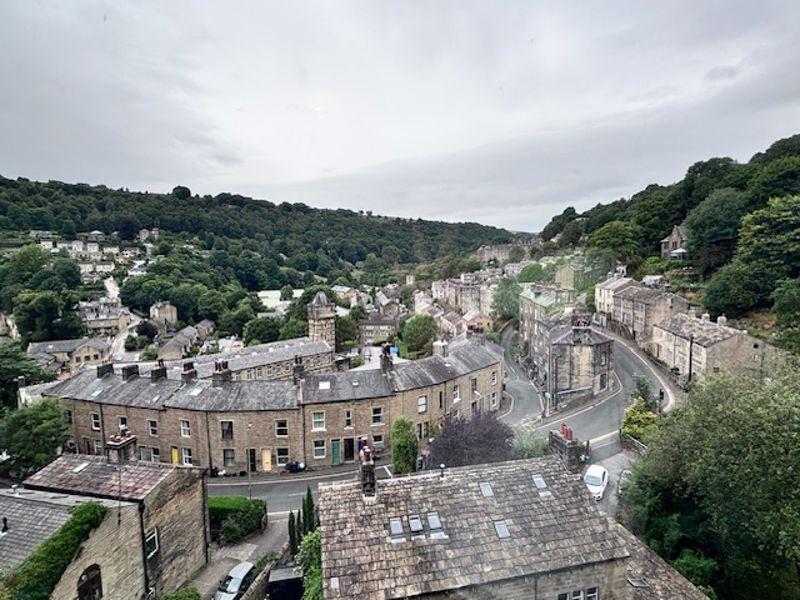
[{"x1": 187, "y1": 517, "x2": 289, "y2": 598}]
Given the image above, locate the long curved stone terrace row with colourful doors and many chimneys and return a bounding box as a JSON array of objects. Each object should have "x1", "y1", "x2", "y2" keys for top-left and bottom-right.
[{"x1": 44, "y1": 336, "x2": 504, "y2": 472}]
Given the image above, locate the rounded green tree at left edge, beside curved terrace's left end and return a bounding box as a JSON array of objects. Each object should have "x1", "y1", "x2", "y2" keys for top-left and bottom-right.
[{"x1": 0, "y1": 398, "x2": 68, "y2": 476}]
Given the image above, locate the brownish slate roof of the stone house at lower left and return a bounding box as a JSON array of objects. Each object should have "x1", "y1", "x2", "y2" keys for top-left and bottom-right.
[{"x1": 24, "y1": 454, "x2": 181, "y2": 501}]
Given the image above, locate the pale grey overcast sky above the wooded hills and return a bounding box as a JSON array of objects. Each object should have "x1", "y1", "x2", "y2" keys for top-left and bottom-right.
[{"x1": 0, "y1": 0, "x2": 800, "y2": 231}]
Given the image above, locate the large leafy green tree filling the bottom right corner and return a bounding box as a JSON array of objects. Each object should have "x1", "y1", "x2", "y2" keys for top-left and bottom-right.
[{"x1": 623, "y1": 363, "x2": 800, "y2": 600}]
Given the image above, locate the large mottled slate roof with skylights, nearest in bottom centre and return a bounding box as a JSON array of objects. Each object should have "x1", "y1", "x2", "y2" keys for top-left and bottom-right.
[{"x1": 319, "y1": 457, "x2": 629, "y2": 599}]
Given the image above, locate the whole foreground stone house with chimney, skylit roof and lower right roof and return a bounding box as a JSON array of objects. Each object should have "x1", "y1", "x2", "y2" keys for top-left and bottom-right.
[{"x1": 319, "y1": 456, "x2": 706, "y2": 600}]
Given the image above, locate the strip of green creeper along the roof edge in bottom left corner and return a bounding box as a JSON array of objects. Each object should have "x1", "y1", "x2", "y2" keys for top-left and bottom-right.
[{"x1": 0, "y1": 502, "x2": 107, "y2": 600}]
